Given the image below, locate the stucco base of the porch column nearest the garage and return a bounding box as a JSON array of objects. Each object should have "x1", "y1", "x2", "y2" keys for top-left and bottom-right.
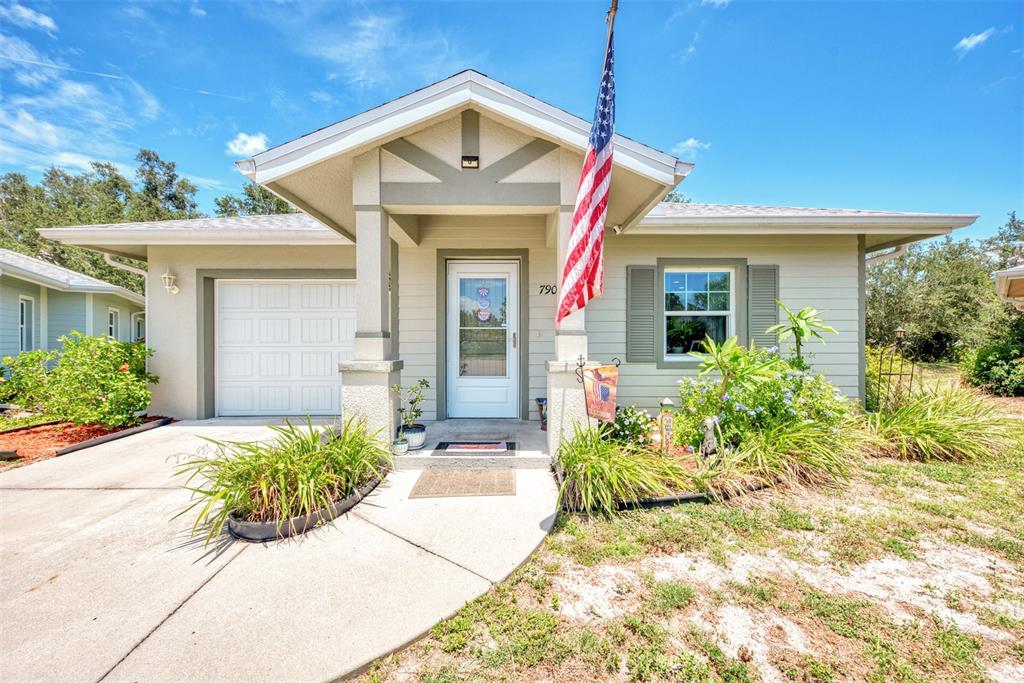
[{"x1": 338, "y1": 360, "x2": 402, "y2": 450}]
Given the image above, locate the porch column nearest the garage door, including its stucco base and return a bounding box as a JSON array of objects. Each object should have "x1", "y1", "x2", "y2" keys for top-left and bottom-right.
[{"x1": 339, "y1": 150, "x2": 401, "y2": 444}]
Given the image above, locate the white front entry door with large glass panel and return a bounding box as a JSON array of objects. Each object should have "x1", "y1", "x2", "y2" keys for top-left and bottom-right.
[{"x1": 445, "y1": 261, "x2": 520, "y2": 418}]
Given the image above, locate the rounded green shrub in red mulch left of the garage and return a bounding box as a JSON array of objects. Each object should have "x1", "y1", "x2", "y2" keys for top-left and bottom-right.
[{"x1": 45, "y1": 332, "x2": 157, "y2": 427}]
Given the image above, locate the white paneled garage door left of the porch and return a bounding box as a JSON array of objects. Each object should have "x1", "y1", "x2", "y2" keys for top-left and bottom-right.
[{"x1": 214, "y1": 280, "x2": 355, "y2": 416}]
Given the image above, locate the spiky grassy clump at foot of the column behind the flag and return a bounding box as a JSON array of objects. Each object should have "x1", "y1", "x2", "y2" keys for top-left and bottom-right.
[{"x1": 558, "y1": 425, "x2": 692, "y2": 514}]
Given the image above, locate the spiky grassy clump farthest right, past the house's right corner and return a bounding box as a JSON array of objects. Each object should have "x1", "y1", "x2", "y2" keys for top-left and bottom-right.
[{"x1": 867, "y1": 386, "x2": 1024, "y2": 461}]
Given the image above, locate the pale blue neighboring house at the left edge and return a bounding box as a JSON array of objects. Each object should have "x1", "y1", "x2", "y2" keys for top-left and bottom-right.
[{"x1": 0, "y1": 249, "x2": 145, "y2": 357}]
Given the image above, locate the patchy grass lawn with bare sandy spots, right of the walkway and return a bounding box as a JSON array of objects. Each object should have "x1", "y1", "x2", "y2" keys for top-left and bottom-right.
[{"x1": 364, "y1": 454, "x2": 1024, "y2": 682}]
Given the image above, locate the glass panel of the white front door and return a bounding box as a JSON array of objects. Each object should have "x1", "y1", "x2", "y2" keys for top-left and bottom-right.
[{"x1": 459, "y1": 278, "x2": 509, "y2": 377}]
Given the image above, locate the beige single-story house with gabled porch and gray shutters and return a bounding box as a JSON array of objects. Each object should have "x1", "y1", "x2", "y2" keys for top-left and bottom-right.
[{"x1": 43, "y1": 71, "x2": 976, "y2": 452}]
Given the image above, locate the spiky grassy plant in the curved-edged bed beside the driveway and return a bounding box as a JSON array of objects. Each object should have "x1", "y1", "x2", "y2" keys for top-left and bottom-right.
[{"x1": 176, "y1": 419, "x2": 390, "y2": 542}]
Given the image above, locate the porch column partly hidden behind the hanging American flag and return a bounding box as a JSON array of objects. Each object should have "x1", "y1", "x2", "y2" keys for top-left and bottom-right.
[{"x1": 547, "y1": 204, "x2": 590, "y2": 457}]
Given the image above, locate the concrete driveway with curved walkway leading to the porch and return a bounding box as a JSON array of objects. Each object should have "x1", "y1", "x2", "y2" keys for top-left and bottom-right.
[{"x1": 0, "y1": 420, "x2": 556, "y2": 681}]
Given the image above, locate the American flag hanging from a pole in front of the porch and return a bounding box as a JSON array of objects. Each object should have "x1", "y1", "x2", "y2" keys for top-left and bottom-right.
[{"x1": 555, "y1": 31, "x2": 615, "y2": 326}]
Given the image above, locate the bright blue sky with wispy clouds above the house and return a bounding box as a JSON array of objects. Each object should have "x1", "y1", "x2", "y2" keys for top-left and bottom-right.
[{"x1": 0, "y1": 0, "x2": 1024, "y2": 237}]
